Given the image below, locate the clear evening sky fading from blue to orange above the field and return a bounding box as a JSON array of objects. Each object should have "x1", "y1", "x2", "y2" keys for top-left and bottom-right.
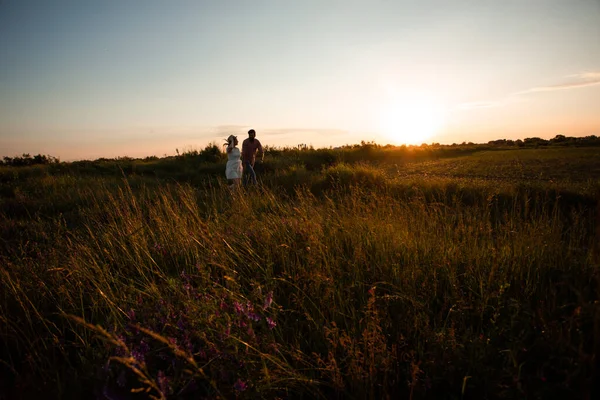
[{"x1": 0, "y1": 0, "x2": 600, "y2": 161}]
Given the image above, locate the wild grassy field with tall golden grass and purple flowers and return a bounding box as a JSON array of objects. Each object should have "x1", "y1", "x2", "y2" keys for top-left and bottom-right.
[{"x1": 0, "y1": 144, "x2": 600, "y2": 399}]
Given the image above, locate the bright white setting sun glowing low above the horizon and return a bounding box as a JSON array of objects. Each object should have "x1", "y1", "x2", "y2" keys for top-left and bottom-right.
[{"x1": 379, "y1": 94, "x2": 446, "y2": 144}]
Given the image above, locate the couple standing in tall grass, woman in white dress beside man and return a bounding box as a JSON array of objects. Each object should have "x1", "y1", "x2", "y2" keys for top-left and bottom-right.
[{"x1": 225, "y1": 129, "x2": 265, "y2": 189}]
